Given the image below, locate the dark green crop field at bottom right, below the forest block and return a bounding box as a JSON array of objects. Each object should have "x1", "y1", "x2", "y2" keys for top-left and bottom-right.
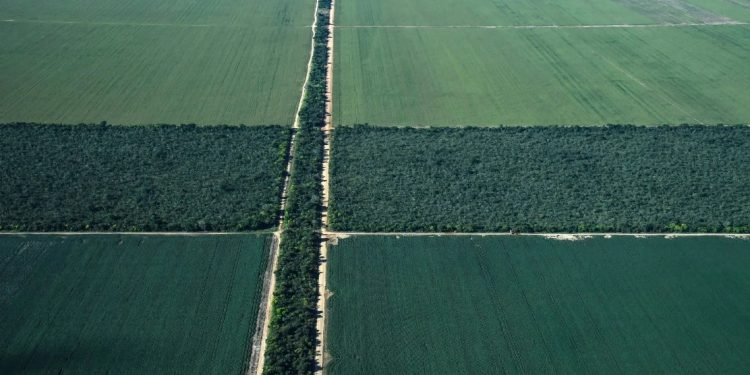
[{"x1": 326, "y1": 236, "x2": 750, "y2": 375}]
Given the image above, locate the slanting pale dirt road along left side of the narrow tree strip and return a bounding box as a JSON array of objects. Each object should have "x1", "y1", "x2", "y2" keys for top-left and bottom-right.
[{"x1": 247, "y1": 1, "x2": 318, "y2": 375}]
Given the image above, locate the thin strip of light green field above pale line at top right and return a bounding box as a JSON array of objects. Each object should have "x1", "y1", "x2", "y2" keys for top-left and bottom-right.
[{"x1": 336, "y1": 0, "x2": 750, "y2": 26}]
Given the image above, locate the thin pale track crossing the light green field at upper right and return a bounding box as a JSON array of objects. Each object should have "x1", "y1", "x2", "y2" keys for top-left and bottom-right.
[{"x1": 335, "y1": 21, "x2": 750, "y2": 30}]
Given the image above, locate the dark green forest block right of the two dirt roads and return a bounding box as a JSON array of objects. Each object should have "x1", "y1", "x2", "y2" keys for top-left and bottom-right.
[{"x1": 329, "y1": 126, "x2": 750, "y2": 232}]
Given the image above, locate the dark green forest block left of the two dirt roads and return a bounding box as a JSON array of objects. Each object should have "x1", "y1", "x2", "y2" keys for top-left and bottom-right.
[{"x1": 0, "y1": 124, "x2": 289, "y2": 231}]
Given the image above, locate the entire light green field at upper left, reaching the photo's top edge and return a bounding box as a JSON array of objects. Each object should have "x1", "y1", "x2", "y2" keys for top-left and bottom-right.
[{"x1": 0, "y1": 0, "x2": 314, "y2": 125}]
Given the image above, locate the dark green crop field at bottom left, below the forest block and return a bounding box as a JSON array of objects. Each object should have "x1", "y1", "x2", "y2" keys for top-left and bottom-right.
[{"x1": 0, "y1": 235, "x2": 270, "y2": 375}]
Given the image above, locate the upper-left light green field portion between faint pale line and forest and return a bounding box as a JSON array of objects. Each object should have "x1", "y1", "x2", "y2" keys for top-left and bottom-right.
[{"x1": 0, "y1": 23, "x2": 310, "y2": 125}]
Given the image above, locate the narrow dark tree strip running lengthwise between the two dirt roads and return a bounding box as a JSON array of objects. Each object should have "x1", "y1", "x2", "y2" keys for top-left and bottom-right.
[{"x1": 264, "y1": 0, "x2": 330, "y2": 375}]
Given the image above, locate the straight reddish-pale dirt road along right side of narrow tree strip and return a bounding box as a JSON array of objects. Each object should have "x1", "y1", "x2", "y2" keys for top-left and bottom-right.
[{"x1": 315, "y1": 0, "x2": 335, "y2": 375}]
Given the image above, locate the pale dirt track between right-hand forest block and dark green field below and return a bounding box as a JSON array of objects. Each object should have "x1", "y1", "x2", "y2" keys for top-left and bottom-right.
[{"x1": 324, "y1": 231, "x2": 750, "y2": 239}]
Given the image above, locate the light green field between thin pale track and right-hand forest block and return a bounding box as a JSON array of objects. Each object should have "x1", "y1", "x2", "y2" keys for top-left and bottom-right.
[{"x1": 334, "y1": 26, "x2": 750, "y2": 126}]
